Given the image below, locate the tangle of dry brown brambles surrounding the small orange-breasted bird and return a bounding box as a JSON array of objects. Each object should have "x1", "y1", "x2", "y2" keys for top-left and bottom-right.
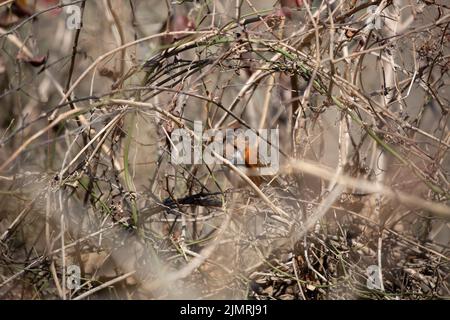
[{"x1": 0, "y1": 1, "x2": 450, "y2": 299}]
